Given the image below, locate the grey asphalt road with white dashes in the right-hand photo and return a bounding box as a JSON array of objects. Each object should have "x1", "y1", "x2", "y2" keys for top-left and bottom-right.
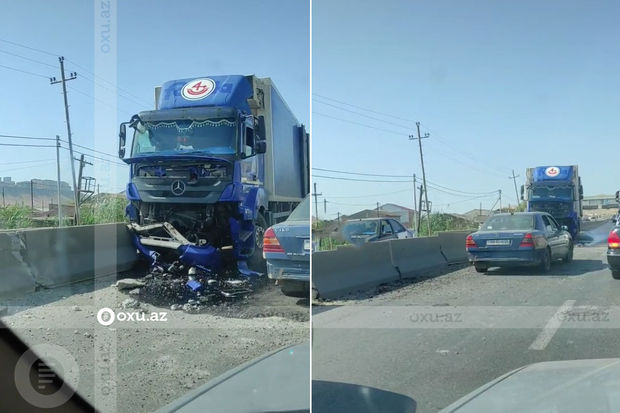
[{"x1": 312, "y1": 223, "x2": 620, "y2": 413}]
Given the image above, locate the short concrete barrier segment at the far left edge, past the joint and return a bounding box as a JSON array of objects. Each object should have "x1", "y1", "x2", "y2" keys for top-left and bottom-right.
[{"x1": 0, "y1": 231, "x2": 35, "y2": 297}]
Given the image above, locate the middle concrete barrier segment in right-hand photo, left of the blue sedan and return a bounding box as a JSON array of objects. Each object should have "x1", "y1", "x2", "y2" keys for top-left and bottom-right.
[{"x1": 389, "y1": 237, "x2": 447, "y2": 278}]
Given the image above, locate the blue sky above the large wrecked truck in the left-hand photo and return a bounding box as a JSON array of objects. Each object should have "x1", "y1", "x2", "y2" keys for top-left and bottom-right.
[{"x1": 0, "y1": 0, "x2": 310, "y2": 192}]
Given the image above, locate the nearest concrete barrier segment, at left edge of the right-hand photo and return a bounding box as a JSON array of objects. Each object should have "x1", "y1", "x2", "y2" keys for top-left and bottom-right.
[{"x1": 312, "y1": 242, "x2": 399, "y2": 299}]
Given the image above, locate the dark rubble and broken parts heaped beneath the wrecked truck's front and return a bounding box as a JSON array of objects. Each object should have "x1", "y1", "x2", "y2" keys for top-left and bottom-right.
[{"x1": 115, "y1": 261, "x2": 254, "y2": 313}]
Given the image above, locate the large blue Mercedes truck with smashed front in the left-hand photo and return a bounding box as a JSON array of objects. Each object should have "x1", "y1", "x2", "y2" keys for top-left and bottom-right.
[{"x1": 119, "y1": 75, "x2": 309, "y2": 275}]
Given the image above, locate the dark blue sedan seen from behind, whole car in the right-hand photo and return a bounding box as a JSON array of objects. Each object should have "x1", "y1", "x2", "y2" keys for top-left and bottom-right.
[{"x1": 465, "y1": 212, "x2": 574, "y2": 272}]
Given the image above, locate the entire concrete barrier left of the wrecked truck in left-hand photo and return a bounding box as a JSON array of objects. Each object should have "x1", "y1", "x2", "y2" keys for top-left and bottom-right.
[{"x1": 0, "y1": 224, "x2": 138, "y2": 295}]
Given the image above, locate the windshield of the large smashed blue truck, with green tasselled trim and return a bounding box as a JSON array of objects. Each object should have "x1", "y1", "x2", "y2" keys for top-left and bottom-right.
[{"x1": 132, "y1": 119, "x2": 237, "y2": 156}]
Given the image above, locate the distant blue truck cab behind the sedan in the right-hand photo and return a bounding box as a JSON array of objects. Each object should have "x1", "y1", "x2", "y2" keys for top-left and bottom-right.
[{"x1": 521, "y1": 165, "x2": 583, "y2": 239}]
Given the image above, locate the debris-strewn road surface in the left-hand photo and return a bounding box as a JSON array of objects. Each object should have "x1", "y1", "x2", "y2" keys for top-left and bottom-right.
[{"x1": 0, "y1": 275, "x2": 309, "y2": 413}]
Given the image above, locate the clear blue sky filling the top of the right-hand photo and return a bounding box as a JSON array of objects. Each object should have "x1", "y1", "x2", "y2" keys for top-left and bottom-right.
[{"x1": 312, "y1": 0, "x2": 620, "y2": 218}]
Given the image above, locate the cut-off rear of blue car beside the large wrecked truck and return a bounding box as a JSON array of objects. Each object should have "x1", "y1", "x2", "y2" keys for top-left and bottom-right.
[{"x1": 263, "y1": 195, "x2": 311, "y2": 298}]
